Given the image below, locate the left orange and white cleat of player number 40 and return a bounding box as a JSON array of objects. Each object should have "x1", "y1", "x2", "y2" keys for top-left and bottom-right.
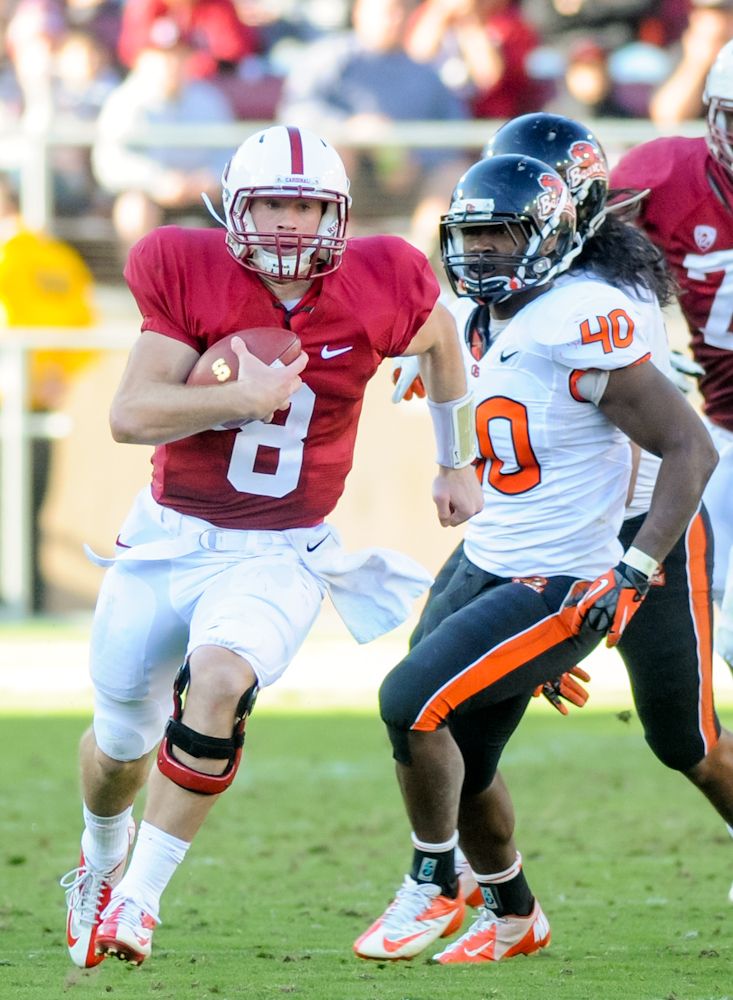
[{"x1": 354, "y1": 875, "x2": 466, "y2": 961}]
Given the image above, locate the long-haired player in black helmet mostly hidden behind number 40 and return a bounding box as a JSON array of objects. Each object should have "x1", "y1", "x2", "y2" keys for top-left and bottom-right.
[{"x1": 428, "y1": 113, "x2": 733, "y2": 952}]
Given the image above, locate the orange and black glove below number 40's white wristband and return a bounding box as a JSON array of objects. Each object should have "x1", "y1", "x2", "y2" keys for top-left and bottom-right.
[{"x1": 568, "y1": 562, "x2": 651, "y2": 646}]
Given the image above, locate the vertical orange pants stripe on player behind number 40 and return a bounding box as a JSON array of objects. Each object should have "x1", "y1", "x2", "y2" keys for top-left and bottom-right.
[{"x1": 685, "y1": 513, "x2": 718, "y2": 754}]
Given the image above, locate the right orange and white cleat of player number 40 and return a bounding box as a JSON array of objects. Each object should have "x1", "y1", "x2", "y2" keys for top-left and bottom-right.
[{"x1": 433, "y1": 900, "x2": 550, "y2": 965}]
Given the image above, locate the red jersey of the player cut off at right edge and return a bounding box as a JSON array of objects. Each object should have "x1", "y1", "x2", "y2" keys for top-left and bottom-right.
[{"x1": 611, "y1": 138, "x2": 733, "y2": 431}]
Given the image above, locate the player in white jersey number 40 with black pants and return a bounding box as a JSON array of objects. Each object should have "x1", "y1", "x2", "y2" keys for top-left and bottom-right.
[{"x1": 355, "y1": 154, "x2": 716, "y2": 964}]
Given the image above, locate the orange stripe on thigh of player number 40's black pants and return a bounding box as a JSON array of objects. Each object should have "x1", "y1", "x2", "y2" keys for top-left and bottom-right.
[{"x1": 412, "y1": 608, "x2": 575, "y2": 733}]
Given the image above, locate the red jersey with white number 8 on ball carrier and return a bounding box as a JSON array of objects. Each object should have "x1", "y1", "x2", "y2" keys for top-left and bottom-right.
[{"x1": 125, "y1": 226, "x2": 439, "y2": 530}]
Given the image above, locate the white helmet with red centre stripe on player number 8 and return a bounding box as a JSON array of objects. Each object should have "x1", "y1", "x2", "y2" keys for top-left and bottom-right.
[{"x1": 222, "y1": 125, "x2": 351, "y2": 281}]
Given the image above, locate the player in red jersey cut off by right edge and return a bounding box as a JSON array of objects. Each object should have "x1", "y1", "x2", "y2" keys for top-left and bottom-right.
[{"x1": 611, "y1": 42, "x2": 733, "y2": 669}]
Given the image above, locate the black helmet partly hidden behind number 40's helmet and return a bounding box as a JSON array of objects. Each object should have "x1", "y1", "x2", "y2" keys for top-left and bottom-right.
[{"x1": 484, "y1": 112, "x2": 610, "y2": 239}]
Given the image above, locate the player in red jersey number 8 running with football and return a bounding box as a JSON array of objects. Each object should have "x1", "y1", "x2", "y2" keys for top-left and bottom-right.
[{"x1": 62, "y1": 126, "x2": 482, "y2": 966}]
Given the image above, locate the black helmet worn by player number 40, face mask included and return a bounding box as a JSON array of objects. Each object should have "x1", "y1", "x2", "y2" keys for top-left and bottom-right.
[{"x1": 440, "y1": 155, "x2": 580, "y2": 302}]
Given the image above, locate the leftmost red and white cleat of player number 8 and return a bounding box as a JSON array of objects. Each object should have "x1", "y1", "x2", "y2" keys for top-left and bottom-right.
[{"x1": 59, "y1": 820, "x2": 135, "y2": 969}]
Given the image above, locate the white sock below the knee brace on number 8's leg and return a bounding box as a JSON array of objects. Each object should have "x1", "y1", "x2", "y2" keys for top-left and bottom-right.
[{"x1": 112, "y1": 820, "x2": 191, "y2": 920}]
